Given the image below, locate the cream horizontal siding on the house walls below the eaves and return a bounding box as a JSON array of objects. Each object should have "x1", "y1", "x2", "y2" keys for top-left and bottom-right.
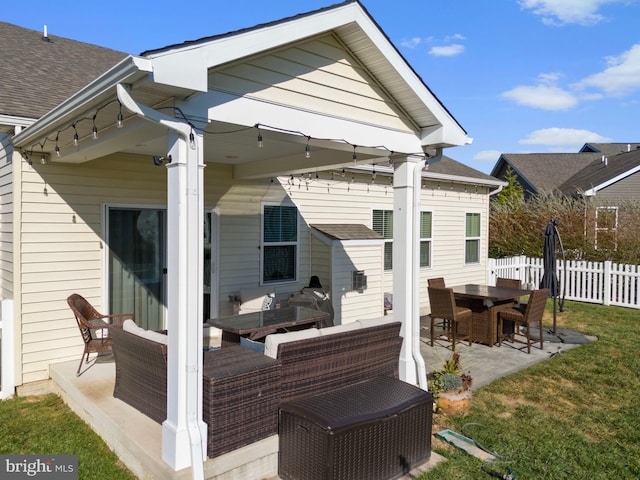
[{"x1": 20, "y1": 156, "x2": 487, "y2": 382}]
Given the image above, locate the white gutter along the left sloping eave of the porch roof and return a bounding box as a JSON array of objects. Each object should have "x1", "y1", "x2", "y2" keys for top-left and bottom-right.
[{"x1": 13, "y1": 55, "x2": 151, "y2": 147}]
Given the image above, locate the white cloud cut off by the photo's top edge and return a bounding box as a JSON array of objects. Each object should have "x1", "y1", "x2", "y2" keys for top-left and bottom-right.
[{"x1": 519, "y1": 0, "x2": 625, "y2": 26}]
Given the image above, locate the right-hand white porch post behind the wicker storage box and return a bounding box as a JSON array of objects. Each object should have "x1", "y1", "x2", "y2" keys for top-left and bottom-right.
[{"x1": 393, "y1": 157, "x2": 424, "y2": 385}]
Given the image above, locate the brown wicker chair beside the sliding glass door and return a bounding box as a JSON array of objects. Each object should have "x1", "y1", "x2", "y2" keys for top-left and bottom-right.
[{"x1": 67, "y1": 293, "x2": 134, "y2": 376}]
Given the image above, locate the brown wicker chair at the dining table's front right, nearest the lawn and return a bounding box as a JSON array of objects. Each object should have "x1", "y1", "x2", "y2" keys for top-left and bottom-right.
[{"x1": 498, "y1": 288, "x2": 549, "y2": 353}]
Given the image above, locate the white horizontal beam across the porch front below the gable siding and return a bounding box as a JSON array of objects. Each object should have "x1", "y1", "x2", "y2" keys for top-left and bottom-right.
[{"x1": 205, "y1": 91, "x2": 422, "y2": 154}]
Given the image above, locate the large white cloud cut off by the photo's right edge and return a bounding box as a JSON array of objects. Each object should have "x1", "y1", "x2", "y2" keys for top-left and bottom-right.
[{"x1": 575, "y1": 44, "x2": 640, "y2": 96}]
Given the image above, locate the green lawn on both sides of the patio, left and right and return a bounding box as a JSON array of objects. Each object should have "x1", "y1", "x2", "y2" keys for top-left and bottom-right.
[{"x1": 0, "y1": 302, "x2": 640, "y2": 480}]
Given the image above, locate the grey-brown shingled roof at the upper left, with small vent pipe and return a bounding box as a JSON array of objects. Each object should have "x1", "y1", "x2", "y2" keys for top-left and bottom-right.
[{"x1": 0, "y1": 22, "x2": 127, "y2": 123}]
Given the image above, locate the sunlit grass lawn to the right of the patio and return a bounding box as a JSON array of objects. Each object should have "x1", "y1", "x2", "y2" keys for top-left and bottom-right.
[{"x1": 419, "y1": 302, "x2": 640, "y2": 480}]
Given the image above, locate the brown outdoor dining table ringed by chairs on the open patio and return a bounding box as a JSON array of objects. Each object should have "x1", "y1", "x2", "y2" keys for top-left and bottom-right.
[{"x1": 451, "y1": 283, "x2": 531, "y2": 347}]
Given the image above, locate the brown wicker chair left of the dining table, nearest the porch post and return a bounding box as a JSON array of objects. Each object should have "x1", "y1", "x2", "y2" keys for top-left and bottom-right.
[{"x1": 427, "y1": 287, "x2": 473, "y2": 351}]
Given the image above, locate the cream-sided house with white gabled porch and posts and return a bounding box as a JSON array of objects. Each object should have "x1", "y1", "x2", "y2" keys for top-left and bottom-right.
[{"x1": 0, "y1": 1, "x2": 504, "y2": 469}]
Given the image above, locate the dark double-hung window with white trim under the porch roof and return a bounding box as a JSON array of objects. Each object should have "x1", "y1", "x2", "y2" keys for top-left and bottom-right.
[{"x1": 261, "y1": 204, "x2": 299, "y2": 283}]
